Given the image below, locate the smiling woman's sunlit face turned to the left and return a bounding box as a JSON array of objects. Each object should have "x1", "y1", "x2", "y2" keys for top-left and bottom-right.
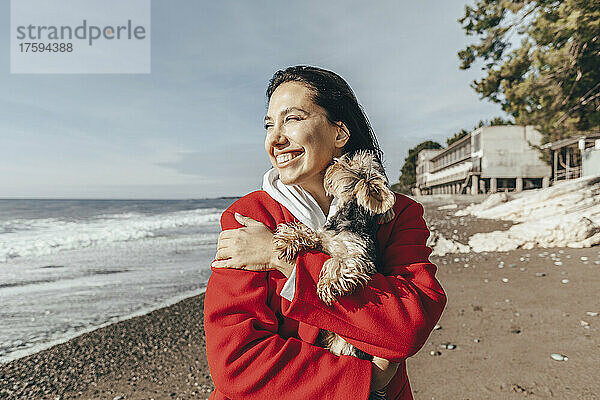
[{"x1": 265, "y1": 82, "x2": 348, "y2": 189}]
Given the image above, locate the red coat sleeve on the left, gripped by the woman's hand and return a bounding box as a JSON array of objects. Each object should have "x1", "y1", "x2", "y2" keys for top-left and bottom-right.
[{"x1": 204, "y1": 197, "x2": 371, "y2": 399}]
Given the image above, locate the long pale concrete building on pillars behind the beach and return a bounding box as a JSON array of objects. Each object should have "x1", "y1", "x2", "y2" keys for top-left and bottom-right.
[{"x1": 416, "y1": 125, "x2": 552, "y2": 194}]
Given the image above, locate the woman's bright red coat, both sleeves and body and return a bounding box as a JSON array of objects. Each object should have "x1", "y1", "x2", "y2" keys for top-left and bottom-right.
[{"x1": 204, "y1": 191, "x2": 446, "y2": 400}]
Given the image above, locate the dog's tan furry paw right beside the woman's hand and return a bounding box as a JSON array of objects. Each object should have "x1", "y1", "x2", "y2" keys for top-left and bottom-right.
[{"x1": 273, "y1": 222, "x2": 320, "y2": 264}]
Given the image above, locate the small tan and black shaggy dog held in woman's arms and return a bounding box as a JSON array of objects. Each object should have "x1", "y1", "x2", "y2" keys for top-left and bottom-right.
[{"x1": 273, "y1": 150, "x2": 396, "y2": 400}]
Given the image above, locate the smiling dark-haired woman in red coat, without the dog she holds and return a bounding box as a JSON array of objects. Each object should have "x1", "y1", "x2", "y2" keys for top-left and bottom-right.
[{"x1": 204, "y1": 66, "x2": 446, "y2": 400}]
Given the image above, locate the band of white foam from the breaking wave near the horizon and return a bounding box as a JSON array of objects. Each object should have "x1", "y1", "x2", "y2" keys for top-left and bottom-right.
[{"x1": 0, "y1": 209, "x2": 222, "y2": 263}]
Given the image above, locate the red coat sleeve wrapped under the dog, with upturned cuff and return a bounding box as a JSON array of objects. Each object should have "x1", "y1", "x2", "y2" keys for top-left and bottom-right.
[{"x1": 282, "y1": 197, "x2": 446, "y2": 362}]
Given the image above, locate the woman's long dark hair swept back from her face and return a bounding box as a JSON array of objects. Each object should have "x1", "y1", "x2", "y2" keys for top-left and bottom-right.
[{"x1": 267, "y1": 65, "x2": 383, "y2": 162}]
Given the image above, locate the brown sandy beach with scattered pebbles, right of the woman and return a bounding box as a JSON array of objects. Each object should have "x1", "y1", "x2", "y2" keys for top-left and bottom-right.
[{"x1": 407, "y1": 201, "x2": 600, "y2": 400}]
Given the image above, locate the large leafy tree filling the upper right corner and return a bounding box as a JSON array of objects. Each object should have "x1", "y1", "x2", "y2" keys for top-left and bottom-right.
[{"x1": 458, "y1": 0, "x2": 600, "y2": 142}]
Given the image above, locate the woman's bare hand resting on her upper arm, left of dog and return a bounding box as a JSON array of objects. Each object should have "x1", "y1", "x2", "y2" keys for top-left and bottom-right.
[{"x1": 212, "y1": 213, "x2": 294, "y2": 278}]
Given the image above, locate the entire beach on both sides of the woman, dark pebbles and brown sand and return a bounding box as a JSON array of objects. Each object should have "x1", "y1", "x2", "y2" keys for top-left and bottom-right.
[{"x1": 0, "y1": 198, "x2": 600, "y2": 400}]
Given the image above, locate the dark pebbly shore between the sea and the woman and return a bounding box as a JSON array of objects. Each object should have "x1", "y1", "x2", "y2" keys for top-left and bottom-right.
[{"x1": 0, "y1": 294, "x2": 213, "y2": 400}]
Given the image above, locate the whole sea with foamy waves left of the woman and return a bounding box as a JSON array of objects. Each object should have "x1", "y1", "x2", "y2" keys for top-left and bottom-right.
[{"x1": 0, "y1": 198, "x2": 236, "y2": 363}]
